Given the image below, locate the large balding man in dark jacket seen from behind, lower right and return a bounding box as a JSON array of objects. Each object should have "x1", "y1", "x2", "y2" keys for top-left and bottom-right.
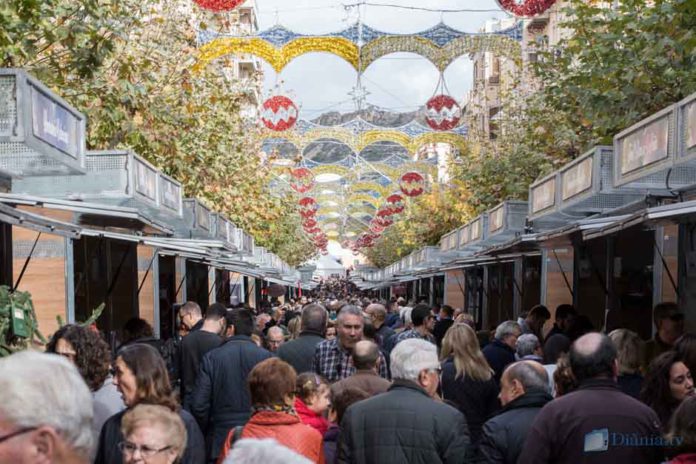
[{"x1": 517, "y1": 332, "x2": 663, "y2": 464}]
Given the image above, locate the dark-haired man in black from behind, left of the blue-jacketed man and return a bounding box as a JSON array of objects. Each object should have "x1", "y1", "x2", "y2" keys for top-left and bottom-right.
[{"x1": 180, "y1": 303, "x2": 227, "y2": 410}]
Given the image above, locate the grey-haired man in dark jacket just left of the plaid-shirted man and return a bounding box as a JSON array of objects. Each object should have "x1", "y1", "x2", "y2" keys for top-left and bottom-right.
[{"x1": 277, "y1": 304, "x2": 328, "y2": 374}]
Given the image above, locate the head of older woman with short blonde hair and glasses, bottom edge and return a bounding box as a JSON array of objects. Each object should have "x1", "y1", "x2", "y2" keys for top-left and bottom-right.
[{"x1": 118, "y1": 404, "x2": 186, "y2": 464}]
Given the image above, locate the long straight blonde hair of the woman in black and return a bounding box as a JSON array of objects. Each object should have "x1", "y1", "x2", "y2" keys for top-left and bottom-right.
[{"x1": 440, "y1": 322, "x2": 493, "y2": 381}]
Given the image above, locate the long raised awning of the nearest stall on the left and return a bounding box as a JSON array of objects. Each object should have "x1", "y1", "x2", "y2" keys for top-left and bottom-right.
[{"x1": 0, "y1": 193, "x2": 173, "y2": 235}]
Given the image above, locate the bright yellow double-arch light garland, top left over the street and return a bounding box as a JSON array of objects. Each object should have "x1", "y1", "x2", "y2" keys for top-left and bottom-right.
[{"x1": 193, "y1": 37, "x2": 359, "y2": 72}]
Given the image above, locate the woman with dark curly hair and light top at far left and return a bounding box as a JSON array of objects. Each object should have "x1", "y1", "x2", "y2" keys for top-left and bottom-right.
[{"x1": 46, "y1": 324, "x2": 125, "y2": 444}]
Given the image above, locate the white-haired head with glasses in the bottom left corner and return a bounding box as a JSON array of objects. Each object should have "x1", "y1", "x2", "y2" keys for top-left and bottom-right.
[{"x1": 0, "y1": 351, "x2": 93, "y2": 464}]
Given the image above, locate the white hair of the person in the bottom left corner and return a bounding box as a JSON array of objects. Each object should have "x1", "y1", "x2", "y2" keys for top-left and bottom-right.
[{"x1": 0, "y1": 351, "x2": 94, "y2": 457}]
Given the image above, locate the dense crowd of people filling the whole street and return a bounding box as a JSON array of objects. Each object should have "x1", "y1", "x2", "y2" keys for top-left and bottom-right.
[{"x1": 0, "y1": 279, "x2": 696, "y2": 464}]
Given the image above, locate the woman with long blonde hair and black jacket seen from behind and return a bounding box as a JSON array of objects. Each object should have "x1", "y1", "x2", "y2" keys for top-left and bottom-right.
[{"x1": 440, "y1": 322, "x2": 500, "y2": 456}]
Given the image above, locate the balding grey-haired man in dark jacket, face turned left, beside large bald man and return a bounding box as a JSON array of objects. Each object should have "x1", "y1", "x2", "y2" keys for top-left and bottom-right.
[{"x1": 479, "y1": 361, "x2": 553, "y2": 464}]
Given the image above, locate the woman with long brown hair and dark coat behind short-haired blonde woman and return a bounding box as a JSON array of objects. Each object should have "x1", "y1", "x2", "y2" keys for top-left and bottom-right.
[{"x1": 94, "y1": 343, "x2": 206, "y2": 464}]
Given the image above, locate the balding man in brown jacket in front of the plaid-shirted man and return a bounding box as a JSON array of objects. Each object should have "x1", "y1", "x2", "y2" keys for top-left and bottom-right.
[{"x1": 331, "y1": 340, "x2": 391, "y2": 396}]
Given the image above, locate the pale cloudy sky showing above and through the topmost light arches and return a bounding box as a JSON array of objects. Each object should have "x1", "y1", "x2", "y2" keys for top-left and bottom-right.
[{"x1": 256, "y1": 0, "x2": 506, "y2": 119}]
